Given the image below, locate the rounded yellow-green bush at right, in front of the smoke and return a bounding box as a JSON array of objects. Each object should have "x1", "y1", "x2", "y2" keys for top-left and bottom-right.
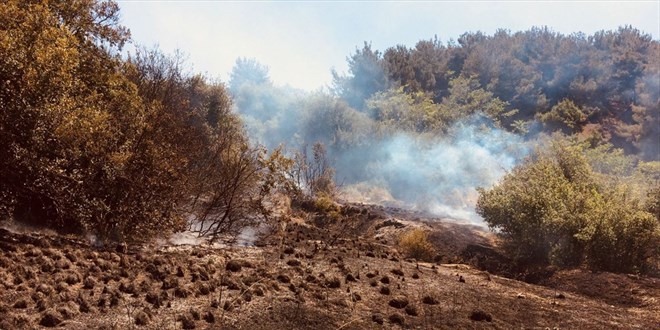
[{"x1": 477, "y1": 140, "x2": 660, "y2": 272}]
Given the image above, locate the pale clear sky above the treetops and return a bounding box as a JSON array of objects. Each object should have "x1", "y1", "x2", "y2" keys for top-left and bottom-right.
[{"x1": 116, "y1": 0, "x2": 660, "y2": 91}]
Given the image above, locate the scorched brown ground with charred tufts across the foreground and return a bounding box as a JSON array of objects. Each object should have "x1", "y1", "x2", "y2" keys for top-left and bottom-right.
[{"x1": 0, "y1": 205, "x2": 660, "y2": 330}]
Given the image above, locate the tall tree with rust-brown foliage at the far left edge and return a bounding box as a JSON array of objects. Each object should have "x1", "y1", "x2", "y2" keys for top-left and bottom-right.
[{"x1": 0, "y1": 0, "x2": 143, "y2": 231}]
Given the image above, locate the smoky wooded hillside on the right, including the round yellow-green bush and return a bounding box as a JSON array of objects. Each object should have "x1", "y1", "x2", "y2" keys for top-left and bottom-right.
[{"x1": 229, "y1": 26, "x2": 660, "y2": 271}]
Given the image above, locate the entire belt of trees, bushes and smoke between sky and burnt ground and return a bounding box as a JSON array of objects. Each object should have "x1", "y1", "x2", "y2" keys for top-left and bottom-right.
[{"x1": 0, "y1": 0, "x2": 660, "y2": 271}]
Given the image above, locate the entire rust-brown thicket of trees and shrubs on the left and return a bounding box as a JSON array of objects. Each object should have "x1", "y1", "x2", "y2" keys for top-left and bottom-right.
[{"x1": 0, "y1": 0, "x2": 279, "y2": 239}]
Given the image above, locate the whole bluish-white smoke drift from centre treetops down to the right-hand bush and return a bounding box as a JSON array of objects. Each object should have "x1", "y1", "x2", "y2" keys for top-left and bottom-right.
[{"x1": 231, "y1": 74, "x2": 526, "y2": 223}]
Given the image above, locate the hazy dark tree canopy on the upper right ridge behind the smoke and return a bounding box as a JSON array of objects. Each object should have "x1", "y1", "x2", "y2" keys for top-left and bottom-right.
[{"x1": 335, "y1": 26, "x2": 660, "y2": 160}]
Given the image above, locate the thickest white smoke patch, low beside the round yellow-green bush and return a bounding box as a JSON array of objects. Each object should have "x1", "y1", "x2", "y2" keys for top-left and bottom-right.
[{"x1": 338, "y1": 117, "x2": 527, "y2": 223}]
